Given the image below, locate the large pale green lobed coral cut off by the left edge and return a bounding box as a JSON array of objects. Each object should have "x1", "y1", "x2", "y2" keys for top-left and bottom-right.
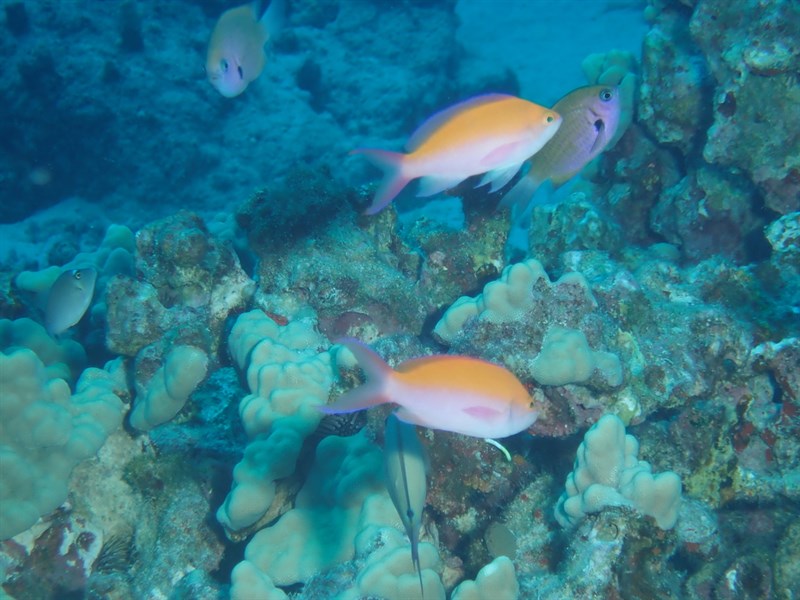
[{"x1": 0, "y1": 348, "x2": 123, "y2": 540}]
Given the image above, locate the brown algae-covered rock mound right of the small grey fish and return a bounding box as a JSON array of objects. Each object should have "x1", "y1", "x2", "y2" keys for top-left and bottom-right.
[{"x1": 106, "y1": 211, "x2": 255, "y2": 356}]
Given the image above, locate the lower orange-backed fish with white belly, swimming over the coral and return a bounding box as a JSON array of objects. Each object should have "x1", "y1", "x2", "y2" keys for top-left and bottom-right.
[{"x1": 319, "y1": 339, "x2": 539, "y2": 438}]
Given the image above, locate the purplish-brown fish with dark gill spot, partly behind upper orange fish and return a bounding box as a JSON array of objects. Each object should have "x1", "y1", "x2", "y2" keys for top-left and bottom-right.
[{"x1": 499, "y1": 85, "x2": 621, "y2": 222}]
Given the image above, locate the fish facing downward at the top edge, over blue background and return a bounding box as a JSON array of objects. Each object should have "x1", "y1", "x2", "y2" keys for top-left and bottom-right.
[{"x1": 206, "y1": 0, "x2": 285, "y2": 98}]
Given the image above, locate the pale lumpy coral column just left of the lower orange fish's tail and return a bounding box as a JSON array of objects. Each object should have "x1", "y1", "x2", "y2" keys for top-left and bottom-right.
[{"x1": 217, "y1": 310, "x2": 333, "y2": 532}]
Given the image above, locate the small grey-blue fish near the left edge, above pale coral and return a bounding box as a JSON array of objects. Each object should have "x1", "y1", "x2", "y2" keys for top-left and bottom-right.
[{"x1": 44, "y1": 267, "x2": 97, "y2": 335}]
